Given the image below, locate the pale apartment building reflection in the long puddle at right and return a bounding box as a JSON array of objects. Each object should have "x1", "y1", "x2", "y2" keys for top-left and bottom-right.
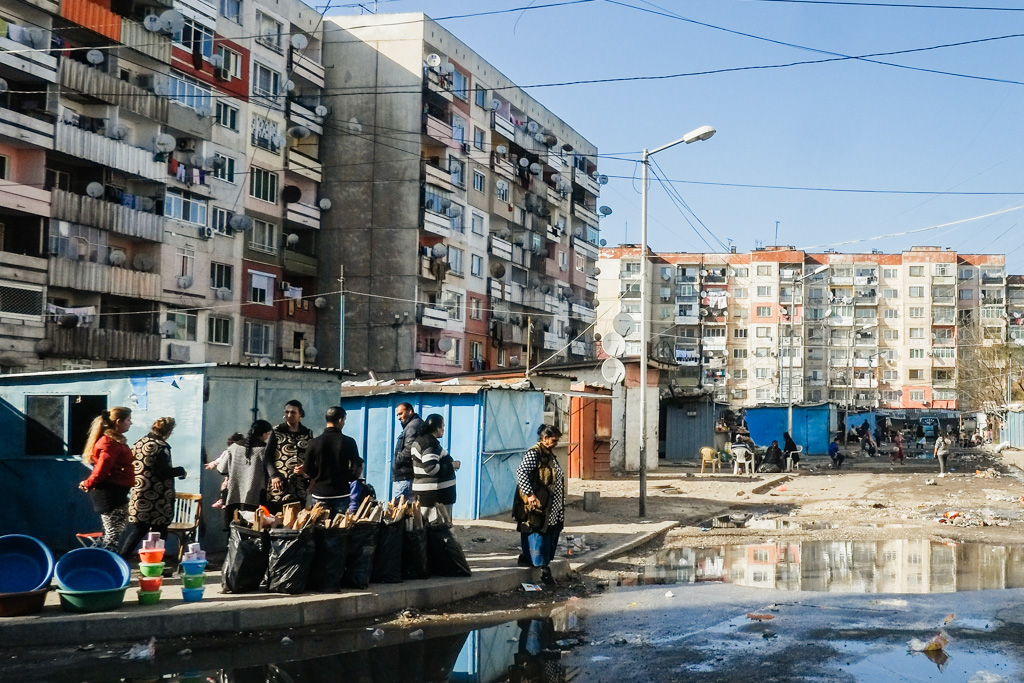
[{"x1": 639, "y1": 540, "x2": 1024, "y2": 593}]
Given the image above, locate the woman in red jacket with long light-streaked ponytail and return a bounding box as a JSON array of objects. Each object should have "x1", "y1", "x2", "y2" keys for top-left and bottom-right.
[{"x1": 78, "y1": 405, "x2": 135, "y2": 552}]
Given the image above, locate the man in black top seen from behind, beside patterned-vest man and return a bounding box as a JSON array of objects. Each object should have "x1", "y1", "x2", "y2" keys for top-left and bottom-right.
[{"x1": 302, "y1": 405, "x2": 362, "y2": 515}]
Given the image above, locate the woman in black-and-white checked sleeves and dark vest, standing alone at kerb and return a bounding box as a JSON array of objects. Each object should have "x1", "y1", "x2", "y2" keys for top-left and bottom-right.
[{"x1": 512, "y1": 425, "x2": 565, "y2": 586}]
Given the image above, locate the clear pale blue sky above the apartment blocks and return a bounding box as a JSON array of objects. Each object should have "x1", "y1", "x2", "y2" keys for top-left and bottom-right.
[{"x1": 331, "y1": 0, "x2": 1024, "y2": 272}]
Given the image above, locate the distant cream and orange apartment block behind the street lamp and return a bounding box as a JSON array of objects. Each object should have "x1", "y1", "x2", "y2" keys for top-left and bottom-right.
[{"x1": 596, "y1": 245, "x2": 1007, "y2": 409}]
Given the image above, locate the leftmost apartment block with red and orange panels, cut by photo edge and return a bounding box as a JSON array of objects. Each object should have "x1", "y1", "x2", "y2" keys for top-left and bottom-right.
[{"x1": 0, "y1": 0, "x2": 326, "y2": 372}]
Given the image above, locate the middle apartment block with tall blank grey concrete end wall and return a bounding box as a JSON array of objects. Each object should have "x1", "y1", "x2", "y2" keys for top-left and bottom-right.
[{"x1": 317, "y1": 13, "x2": 599, "y2": 377}]
